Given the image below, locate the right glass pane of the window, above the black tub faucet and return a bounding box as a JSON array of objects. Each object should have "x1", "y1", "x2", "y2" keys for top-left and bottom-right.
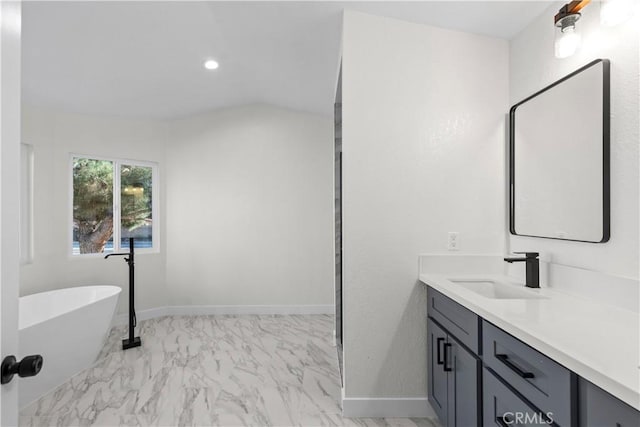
[{"x1": 120, "y1": 165, "x2": 153, "y2": 249}]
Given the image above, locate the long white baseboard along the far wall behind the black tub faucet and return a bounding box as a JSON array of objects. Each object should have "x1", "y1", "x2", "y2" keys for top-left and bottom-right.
[{"x1": 113, "y1": 304, "x2": 335, "y2": 326}]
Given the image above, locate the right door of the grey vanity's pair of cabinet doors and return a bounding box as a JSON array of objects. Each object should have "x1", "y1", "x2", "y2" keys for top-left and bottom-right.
[{"x1": 445, "y1": 336, "x2": 480, "y2": 427}]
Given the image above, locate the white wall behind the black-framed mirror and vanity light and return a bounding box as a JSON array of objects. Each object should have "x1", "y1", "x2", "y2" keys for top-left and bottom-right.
[{"x1": 509, "y1": 2, "x2": 640, "y2": 280}]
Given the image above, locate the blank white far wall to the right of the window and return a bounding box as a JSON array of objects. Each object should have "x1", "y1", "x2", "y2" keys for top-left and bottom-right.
[{"x1": 165, "y1": 106, "x2": 334, "y2": 309}]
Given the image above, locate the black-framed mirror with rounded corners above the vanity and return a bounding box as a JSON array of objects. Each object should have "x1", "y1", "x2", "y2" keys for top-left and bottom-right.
[{"x1": 509, "y1": 59, "x2": 611, "y2": 243}]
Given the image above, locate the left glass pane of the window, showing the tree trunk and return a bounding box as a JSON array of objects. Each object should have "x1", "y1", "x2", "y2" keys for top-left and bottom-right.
[{"x1": 73, "y1": 157, "x2": 113, "y2": 254}]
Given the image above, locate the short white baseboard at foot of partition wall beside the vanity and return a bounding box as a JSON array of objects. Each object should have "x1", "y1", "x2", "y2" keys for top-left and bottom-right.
[{"x1": 342, "y1": 397, "x2": 436, "y2": 418}]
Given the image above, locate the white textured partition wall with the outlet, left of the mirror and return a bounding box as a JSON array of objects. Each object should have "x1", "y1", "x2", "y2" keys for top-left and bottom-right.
[{"x1": 342, "y1": 11, "x2": 508, "y2": 405}]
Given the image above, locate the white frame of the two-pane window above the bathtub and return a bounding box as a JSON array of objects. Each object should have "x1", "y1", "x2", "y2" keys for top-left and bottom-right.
[{"x1": 67, "y1": 153, "x2": 160, "y2": 259}]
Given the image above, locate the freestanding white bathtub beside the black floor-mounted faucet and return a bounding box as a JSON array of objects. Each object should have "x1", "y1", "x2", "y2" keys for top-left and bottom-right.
[{"x1": 18, "y1": 286, "x2": 121, "y2": 408}]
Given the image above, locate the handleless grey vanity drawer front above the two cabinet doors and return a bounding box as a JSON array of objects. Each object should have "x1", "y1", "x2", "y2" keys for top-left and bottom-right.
[{"x1": 427, "y1": 287, "x2": 480, "y2": 354}]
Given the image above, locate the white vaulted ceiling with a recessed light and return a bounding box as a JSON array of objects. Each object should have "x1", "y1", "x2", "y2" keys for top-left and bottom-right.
[{"x1": 22, "y1": 1, "x2": 550, "y2": 119}]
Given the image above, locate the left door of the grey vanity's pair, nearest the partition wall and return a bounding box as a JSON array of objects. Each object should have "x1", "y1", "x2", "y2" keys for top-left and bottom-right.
[{"x1": 427, "y1": 319, "x2": 448, "y2": 426}]
